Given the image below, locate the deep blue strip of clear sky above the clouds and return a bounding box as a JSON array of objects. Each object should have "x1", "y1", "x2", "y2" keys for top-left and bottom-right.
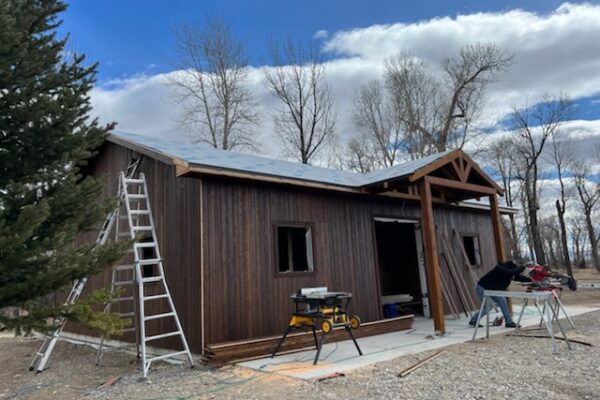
[{"x1": 61, "y1": 0, "x2": 562, "y2": 82}]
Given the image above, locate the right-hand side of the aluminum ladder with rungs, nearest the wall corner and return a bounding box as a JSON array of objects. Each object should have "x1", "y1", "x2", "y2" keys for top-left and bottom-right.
[{"x1": 96, "y1": 173, "x2": 195, "y2": 378}]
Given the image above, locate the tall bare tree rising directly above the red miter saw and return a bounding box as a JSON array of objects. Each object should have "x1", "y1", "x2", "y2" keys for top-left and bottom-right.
[{"x1": 511, "y1": 96, "x2": 573, "y2": 264}]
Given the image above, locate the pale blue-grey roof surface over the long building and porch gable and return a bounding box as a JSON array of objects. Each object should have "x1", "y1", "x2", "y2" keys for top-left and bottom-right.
[{"x1": 112, "y1": 132, "x2": 450, "y2": 188}]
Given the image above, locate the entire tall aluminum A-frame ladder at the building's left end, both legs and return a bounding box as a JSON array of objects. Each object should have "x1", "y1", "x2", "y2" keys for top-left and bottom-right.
[{"x1": 29, "y1": 158, "x2": 195, "y2": 377}]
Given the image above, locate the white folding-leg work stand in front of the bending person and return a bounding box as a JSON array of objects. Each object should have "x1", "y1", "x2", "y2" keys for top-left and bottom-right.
[{"x1": 471, "y1": 290, "x2": 571, "y2": 354}]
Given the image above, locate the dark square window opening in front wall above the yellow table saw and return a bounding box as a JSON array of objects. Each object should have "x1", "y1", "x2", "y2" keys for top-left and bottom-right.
[{"x1": 277, "y1": 226, "x2": 314, "y2": 273}]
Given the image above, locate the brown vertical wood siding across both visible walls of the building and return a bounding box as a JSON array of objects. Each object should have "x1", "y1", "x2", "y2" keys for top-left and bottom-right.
[{"x1": 68, "y1": 143, "x2": 496, "y2": 353}]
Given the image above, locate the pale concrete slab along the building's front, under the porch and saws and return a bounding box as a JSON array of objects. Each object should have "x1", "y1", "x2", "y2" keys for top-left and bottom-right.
[{"x1": 238, "y1": 305, "x2": 599, "y2": 380}]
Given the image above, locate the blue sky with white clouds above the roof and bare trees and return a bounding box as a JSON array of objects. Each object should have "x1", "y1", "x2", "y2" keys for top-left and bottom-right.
[{"x1": 62, "y1": 0, "x2": 600, "y2": 183}]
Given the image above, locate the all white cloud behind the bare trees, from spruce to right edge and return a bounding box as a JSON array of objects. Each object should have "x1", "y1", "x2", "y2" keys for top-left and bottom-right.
[{"x1": 92, "y1": 3, "x2": 600, "y2": 161}]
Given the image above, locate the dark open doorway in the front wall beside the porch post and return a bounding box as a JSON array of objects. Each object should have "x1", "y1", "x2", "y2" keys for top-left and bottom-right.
[{"x1": 375, "y1": 218, "x2": 430, "y2": 317}]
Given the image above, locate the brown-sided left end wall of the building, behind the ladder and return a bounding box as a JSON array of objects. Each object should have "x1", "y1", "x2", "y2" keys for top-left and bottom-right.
[{"x1": 67, "y1": 143, "x2": 202, "y2": 353}]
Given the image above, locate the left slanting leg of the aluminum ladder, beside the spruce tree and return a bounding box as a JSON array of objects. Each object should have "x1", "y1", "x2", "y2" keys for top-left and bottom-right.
[{"x1": 29, "y1": 157, "x2": 141, "y2": 373}]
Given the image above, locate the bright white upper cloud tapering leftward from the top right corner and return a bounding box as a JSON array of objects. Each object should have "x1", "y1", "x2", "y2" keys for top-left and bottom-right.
[{"x1": 325, "y1": 3, "x2": 600, "y2": 116}]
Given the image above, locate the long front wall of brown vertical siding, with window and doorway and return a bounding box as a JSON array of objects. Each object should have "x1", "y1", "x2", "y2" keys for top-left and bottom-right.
[{"x1": 203, "y1": 178, "x2": 495, "y2": 343}]
